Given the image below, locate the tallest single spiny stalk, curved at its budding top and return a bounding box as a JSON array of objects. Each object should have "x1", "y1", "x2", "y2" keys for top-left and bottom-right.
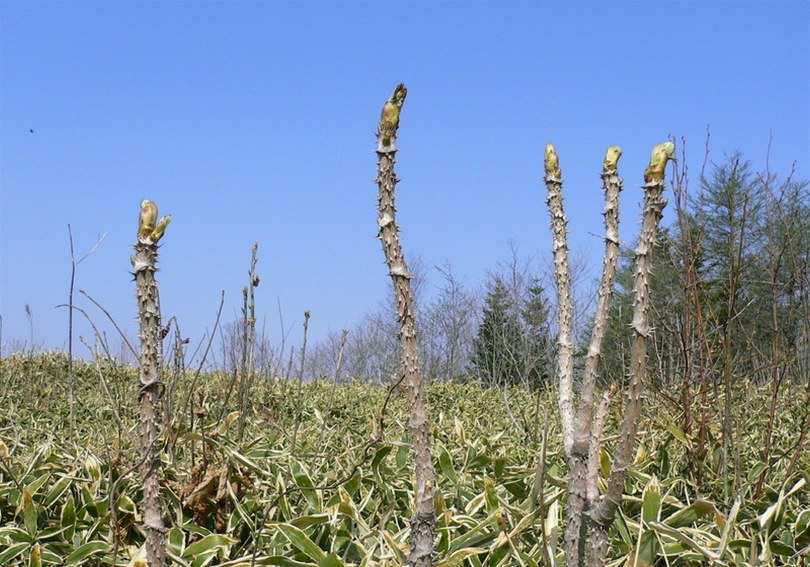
[{"x1": 377, "y1": 83, "x2": 436, "y2": 567}]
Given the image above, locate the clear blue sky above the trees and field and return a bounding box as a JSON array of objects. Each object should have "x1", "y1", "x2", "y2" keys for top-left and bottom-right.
[{"x1": 0, "y1": 0, "x2": 810, "y2": 354}]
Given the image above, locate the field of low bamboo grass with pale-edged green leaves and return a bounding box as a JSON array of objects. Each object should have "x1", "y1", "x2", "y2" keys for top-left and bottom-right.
[{"x1": 0, "y1": 352, "x2": 810, "y2": 567}]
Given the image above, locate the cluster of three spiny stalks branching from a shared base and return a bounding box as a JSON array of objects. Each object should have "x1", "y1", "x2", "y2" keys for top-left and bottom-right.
[{"x1": 545, "y1": 142, "x2": 675, "y2": 567}]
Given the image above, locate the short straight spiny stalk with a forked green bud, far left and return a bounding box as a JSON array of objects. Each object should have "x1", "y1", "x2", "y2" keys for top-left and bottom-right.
[{"x1": 131, "y1": 199, "x2": 172, "y2": 567}]
